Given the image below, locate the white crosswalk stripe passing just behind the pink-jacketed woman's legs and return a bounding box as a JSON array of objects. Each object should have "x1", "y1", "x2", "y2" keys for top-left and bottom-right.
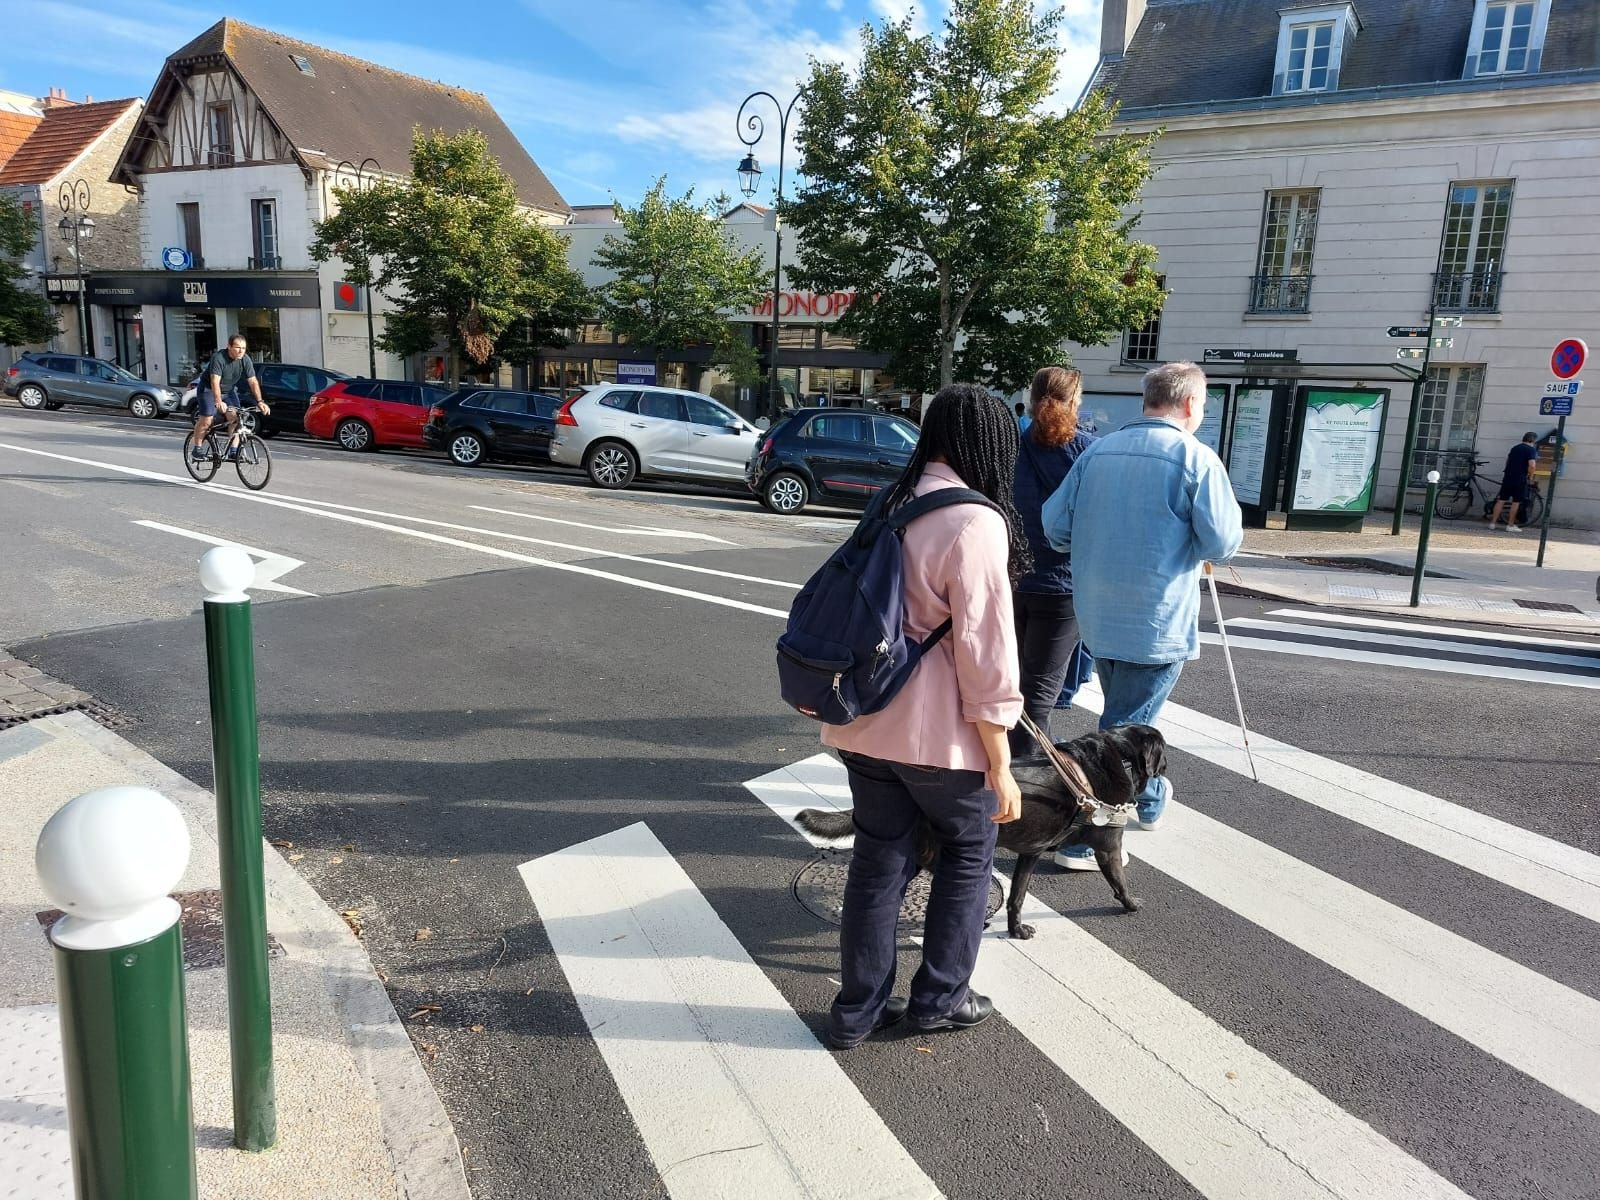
[{"x1": 746, "y1": 754, "x2": 1464, "y2": 1200}]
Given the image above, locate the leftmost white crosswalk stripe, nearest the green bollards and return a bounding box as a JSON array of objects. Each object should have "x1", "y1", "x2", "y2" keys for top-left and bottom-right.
[{"x1": 518, "y1": 822, "x2": 939, "y2": 1200}]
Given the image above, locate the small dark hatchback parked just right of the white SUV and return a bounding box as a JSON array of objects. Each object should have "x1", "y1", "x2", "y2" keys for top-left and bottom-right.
[{"x1": 744, "y1": 408, "x2": 920, "y2": 515}]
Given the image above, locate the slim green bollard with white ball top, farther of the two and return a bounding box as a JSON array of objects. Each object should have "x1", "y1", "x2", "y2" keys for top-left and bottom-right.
[{"x1": 200, "y1": 546, "x2": 278, "y2": 1150}]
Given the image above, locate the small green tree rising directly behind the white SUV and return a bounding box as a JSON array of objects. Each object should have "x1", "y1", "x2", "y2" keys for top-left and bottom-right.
[{"x1": 594, "y1": 176, "x2": 768, "y2": 384}]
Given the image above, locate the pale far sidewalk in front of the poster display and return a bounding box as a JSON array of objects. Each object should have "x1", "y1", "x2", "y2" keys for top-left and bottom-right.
[{"x1": 1218, "y1": 512, "x2": 1600, "y2": 635}]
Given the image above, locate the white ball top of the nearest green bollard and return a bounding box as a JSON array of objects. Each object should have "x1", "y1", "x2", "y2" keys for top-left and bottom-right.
[{"x1": 34, "y1": 787, "x2": 189, "y2": 950}]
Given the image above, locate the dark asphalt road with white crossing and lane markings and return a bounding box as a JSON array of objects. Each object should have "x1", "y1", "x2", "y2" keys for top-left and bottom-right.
[{"x1": 0, "y1": 405, "x2": 1600, "y2": 1200}]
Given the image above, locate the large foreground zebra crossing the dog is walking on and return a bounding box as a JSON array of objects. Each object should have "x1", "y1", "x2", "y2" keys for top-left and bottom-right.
[{"x1": 520, "y1": 686, "x2": 1600, "y2": 1200}]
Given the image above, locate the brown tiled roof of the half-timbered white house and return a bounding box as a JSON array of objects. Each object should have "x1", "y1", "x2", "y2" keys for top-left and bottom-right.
[{"x1": 132, "y1": 18, "x2": 568, "y2": 213}]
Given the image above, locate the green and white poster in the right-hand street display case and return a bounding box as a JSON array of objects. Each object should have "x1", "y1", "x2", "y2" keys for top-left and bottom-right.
[{"x1": 1291, "y1": 387, "x2": 1389, "y2": 512}]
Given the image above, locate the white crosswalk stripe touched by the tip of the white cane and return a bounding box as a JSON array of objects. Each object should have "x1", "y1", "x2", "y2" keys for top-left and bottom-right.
[{"x1": 1072, "y1": 682, "x2": 1600, "y2": 922}]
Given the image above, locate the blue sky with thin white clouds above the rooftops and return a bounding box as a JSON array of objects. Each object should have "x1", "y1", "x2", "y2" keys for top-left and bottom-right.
[{"x1": 0, "y1": 0, "x2": 1099, "y2": 205}]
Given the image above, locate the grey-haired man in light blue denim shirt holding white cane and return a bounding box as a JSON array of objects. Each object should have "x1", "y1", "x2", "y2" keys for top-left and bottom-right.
[{"x1": 1045, "y1": 363, "x2": 1245, "y2": 867}]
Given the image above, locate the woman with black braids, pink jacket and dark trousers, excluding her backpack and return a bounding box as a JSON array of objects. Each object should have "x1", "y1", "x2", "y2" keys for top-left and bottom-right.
[{"x1": 822, "y1": 384, "x2": 1030, "y2": 1050}]
